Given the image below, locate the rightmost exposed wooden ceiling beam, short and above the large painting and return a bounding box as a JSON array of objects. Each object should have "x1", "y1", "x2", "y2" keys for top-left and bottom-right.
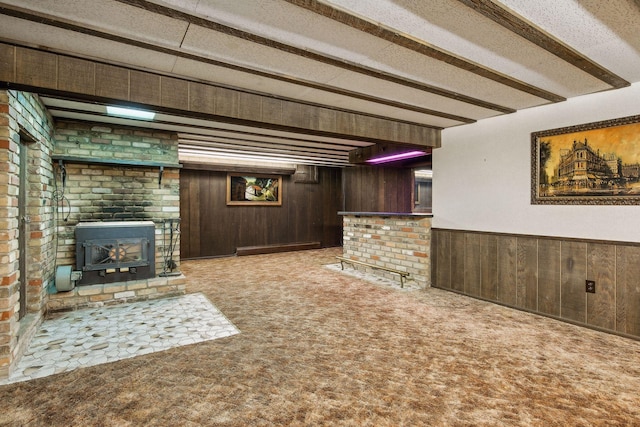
[{"x1": 458, "y1": 0, "x2": 638, "y2": 89}]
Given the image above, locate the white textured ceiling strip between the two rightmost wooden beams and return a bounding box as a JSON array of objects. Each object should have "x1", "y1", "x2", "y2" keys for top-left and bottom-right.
[{"x1": 327, "y1": 0, "x2": 608, "y2": 97}]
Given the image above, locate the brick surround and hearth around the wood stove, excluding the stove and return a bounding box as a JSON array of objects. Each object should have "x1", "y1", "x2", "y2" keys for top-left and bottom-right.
[{"x1": 49, "y1": 121, "x2": 184, "y2": 310}]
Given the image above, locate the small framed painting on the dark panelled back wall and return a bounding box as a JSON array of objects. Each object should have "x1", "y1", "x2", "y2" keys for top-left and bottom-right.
[{"x1": 227, "y1": 173, "x2": 282, "y2": 206}]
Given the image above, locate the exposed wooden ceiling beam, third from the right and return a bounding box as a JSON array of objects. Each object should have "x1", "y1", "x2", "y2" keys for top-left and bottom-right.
[{"x1": 115, "y1": 0, "x2": 515, "y2": 113}]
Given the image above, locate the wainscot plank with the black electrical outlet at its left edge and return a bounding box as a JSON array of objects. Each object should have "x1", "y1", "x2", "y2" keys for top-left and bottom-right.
[{"x1": 587, "y1": 243, "x2": 616, "y2": 330}]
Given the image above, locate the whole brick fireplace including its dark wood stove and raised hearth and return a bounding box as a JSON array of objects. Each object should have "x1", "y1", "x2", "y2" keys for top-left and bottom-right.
[{"x1": 47, "y1": 121, "x2": 185, "y2": 311}]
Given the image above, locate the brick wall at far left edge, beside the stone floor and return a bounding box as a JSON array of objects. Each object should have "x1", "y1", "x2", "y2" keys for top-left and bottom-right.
[{"x1": 0, "y1": 91, "x2": 54, "y2": 377}]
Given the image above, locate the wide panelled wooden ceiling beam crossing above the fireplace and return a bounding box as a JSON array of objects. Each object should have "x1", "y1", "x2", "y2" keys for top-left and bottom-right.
[{"x1": 0, "y1": 43, "x2": 441, "y2": 147}]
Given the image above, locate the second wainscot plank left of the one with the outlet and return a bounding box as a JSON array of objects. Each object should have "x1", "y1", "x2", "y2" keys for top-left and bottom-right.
[{"x1": 538, "y1": 239, "x2": 560, "y2": 316}]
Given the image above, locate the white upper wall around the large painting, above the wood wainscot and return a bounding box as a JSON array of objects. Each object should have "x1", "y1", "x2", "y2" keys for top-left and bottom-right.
[{"x1": 433, "y1": 83, "x2": 640, "y2": 242}]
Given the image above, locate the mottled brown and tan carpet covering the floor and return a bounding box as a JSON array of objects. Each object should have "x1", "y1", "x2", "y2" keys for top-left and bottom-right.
[{"x1": 0, "y1": 248, "x2": 640, "y2": 426}]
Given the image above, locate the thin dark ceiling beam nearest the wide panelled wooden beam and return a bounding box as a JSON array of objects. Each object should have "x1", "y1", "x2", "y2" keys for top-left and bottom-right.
[{"x1": 0, "y1": 6, "x2": 476, "y2": 123}]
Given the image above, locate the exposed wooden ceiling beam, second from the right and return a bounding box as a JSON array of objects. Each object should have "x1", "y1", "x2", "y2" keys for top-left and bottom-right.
[{"x1": 285, "y1": 0, "x2": 566, "y2": 102}]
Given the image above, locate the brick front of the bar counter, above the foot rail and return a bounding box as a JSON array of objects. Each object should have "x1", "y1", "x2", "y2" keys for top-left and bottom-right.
[{"x1": 342, "y1": 213, "x2": 431, "y2": 288}]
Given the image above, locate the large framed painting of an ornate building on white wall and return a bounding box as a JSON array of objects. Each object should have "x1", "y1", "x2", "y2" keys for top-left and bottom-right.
[{"x1": 531, "y1": 116, "x2": 640, "y2": 205}]
